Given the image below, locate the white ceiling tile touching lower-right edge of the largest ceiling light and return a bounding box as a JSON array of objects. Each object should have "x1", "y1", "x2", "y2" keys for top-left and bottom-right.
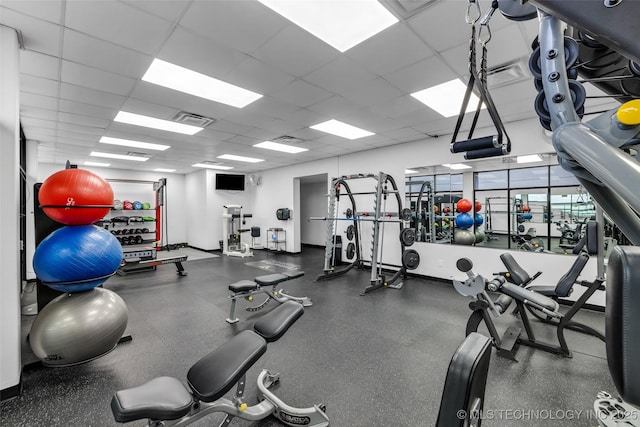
[{"x1": 345, "y1": 23, "x2": 433, "y2": 75}]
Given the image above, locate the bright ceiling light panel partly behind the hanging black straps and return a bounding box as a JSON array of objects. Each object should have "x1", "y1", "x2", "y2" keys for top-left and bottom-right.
[{"x1": 411, "y1": 79, "x2": 487, "y2": 117}]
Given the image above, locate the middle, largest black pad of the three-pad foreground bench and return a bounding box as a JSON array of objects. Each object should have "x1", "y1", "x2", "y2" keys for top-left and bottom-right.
[{"x1": 187, "y1": 330, "x2": 267, "y2": 402}]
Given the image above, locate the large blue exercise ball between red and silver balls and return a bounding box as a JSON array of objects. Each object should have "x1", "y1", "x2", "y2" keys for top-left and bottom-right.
[{"x1": 33, "y1": 225, "x2": 123, "y2": 292}]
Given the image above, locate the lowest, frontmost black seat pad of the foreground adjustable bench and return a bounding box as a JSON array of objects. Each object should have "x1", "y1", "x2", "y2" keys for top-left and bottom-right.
[{"x1": 111, "y1": 377, "x2": 193, "y2": 423}]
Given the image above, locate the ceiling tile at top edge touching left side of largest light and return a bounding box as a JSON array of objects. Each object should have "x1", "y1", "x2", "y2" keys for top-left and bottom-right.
[{"x1": 180, "y1": 0, "x2": 287, "y2": 53}]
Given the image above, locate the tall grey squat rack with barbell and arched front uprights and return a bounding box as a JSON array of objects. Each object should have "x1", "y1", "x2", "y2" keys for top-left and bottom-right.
[{"x1": 310, "y1": 172, "x2": 417, "y2": 295}]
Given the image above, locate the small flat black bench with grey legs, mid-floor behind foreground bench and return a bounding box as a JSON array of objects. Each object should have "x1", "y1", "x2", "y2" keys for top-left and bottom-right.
[{"x1": 226, "y1": 270, "x2": 313, "y2": 324}]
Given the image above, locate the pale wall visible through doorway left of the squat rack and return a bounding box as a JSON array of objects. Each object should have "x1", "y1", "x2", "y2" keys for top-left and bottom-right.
[{"x1": 300, "y1": 182, "x2": 329, "y2": 246}]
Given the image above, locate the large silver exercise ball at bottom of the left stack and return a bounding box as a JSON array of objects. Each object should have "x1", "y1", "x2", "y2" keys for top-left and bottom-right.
[{"x1": 29, "y1": 288, "x2": 128, "y2": 366}]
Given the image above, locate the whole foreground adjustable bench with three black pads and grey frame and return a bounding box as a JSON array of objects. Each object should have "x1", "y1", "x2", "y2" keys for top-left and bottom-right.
[{"x1": 111, "y1": 301, "x2": 329, "y2": 427}]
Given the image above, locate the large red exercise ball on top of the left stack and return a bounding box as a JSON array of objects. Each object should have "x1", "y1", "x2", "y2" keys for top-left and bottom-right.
[{"x1": 38, "y1": 169, "x2": 113, "y2": 225}]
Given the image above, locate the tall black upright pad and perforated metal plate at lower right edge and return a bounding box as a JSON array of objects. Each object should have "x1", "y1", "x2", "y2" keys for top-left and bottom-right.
[{"x1": 593, "y1": 246, "x2": 640, "y2": 427}]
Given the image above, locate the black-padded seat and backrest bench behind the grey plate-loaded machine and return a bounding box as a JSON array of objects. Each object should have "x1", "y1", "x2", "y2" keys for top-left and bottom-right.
[{"x1": 500, "y1": 253, "x2": 604, "y2": 341}]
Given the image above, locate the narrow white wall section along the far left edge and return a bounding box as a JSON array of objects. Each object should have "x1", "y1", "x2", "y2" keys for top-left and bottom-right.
[{"x1": 0, "y1": 26, "x2": 21, "y2": 396}]
